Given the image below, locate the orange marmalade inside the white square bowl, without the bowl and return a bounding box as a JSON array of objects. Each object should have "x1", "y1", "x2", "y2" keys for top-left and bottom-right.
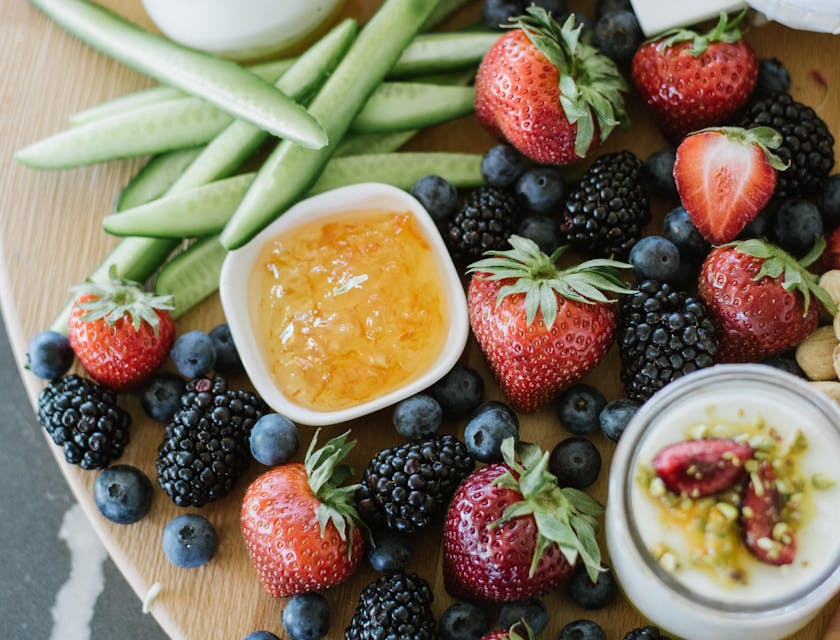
[{"x1": 249, "y1": 209, "x2": 447, "y2": 411}]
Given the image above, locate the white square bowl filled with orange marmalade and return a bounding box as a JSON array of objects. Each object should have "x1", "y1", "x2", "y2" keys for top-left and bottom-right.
[{"x1": 220, "y1": 183, "x2": 469, "y2": 425}]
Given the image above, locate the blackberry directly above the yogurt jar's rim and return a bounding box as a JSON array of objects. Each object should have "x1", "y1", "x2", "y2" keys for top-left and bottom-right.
[{"x1": 618, "y1": 280, "x2": 718, "y2": 402}]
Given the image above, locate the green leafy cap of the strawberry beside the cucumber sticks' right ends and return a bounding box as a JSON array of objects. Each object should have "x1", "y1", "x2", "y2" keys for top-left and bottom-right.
[{"x1": 506, "y1": 6, "x2": 628, "y2": 158}]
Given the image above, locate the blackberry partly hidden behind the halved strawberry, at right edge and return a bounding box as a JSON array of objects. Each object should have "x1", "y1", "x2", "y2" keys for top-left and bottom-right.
[{"x1": 741, "y1": 92, "x2": 834, "y2": 199}]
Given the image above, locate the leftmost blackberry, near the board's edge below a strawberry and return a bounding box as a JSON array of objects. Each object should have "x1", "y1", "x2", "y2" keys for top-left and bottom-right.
[{"x1": 38, "y1": 375, "x2": 131, "y2": 469}]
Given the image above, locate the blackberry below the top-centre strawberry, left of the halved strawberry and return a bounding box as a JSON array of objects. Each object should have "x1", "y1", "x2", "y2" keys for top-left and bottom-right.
[{"x1": 560, "y1": 151, "x2": 650, "y2": 260}]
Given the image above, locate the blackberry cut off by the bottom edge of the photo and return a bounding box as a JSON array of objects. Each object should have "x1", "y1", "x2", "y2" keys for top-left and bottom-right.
[{"x1": 344, "y1": 573, "x2": 438, "y2": 640}]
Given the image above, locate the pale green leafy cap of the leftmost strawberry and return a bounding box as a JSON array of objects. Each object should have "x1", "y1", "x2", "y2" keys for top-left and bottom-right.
[{"x1": 71, "y1": 265, "x2": 175, "y2": 335}]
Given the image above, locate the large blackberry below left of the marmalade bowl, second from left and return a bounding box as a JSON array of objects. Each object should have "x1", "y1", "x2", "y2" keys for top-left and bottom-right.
[{"x1": 156, "y1": 376, "x2": 267, "y2": 507}]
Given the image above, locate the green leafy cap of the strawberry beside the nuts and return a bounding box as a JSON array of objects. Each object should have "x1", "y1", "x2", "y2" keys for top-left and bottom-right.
[{"x1": 724, "y1": 237, "x2": 837, "y2": 316}]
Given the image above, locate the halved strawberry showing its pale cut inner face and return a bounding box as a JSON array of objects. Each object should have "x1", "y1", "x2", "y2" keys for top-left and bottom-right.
[{"x1": 674, "y1": 127, "x2": 787, "y2": 244}]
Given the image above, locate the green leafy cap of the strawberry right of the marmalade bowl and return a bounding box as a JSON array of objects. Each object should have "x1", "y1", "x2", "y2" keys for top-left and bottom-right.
[{"x1": 467, "y1": 235, "x2": 636, "y2": 329}]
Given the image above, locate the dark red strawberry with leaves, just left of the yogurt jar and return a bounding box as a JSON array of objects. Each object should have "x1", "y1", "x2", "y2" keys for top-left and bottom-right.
[{"x1": 443, "y1": 438, "x2": 603, "y2": 602}]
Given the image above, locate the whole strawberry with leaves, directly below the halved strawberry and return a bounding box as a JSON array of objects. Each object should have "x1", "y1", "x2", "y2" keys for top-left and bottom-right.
[{"x1": 697, "y1": 238, "x2": 837, "y2": 362}]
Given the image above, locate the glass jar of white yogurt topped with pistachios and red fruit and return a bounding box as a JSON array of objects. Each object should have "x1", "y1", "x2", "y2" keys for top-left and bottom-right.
[{"x1": 606, "y1": 365, "x2": 840, "y2": 640}]
